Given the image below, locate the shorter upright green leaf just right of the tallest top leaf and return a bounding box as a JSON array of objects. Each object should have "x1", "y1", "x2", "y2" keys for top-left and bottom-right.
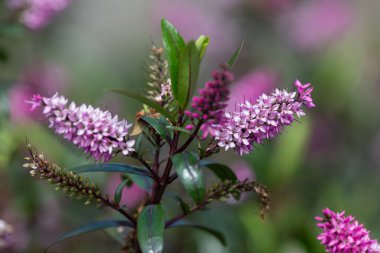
[{"x1": 177, "y1": 41, "x2": 201, "y2": 109}]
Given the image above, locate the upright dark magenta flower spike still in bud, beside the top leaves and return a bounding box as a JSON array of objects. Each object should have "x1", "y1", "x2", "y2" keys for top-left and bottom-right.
[{"x1": 186, "y1": 66, "x2": 233, "y2": 138}]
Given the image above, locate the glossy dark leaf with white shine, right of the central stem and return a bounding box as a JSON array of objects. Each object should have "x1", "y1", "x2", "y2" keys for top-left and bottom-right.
[{"x1": 171, "y1": 152, "x2": 206, "y2": 204}]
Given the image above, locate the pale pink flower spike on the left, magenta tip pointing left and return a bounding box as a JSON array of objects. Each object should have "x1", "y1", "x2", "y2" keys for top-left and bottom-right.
[{"x1": 26, "y1": 93, "x2": 135, "y2": 162}]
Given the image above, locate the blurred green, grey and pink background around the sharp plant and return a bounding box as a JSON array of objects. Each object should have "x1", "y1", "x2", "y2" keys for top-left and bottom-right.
[{"x1": 0, "y1": 0, "x2": 380, "y2": 253}]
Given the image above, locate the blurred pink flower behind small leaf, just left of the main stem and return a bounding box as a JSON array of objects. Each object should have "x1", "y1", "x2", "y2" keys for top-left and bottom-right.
[{"x1": 106, "y1": 173, "x2": 147, "y2": 209}]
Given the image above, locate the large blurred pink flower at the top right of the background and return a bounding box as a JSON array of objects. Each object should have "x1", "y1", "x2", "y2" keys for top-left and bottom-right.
[{"x1": 279, "y1": 0, "x2": 353, "y2": 50}]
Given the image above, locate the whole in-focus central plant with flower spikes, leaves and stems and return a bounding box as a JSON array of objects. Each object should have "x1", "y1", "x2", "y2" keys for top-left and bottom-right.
[{"x1": 24, "y1": 19, "x2": 315, "y2": 253}]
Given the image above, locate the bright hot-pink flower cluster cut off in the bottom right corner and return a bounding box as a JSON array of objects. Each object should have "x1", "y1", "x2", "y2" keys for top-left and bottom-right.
[{"x1": 315, "y1": 208, "x2": 380, "y2": 253}]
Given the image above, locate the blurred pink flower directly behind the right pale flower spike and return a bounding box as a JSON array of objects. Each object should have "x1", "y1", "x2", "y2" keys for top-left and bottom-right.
[{"x1": 226, "y1": 68, "x2": 278, "y2": 112}]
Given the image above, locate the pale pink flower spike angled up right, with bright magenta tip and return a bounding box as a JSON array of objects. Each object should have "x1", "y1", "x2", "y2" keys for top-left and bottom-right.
[{"x1": 214, "y1": 80, "x2": 315, "y2": 155}]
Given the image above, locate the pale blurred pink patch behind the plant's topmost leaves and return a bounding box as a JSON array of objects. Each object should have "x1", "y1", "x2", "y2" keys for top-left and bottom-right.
[{"x1": 152, "y1": 0, "x2": 238, "y2": 55}]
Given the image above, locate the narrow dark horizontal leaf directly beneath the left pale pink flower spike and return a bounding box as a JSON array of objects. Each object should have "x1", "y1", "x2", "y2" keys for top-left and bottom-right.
[{"x1": 70, "y1": 163, "x2": 151, "y2": 177}]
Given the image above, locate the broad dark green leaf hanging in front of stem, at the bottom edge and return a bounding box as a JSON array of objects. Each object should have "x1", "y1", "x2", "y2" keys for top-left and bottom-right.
[{"x1": 137, "y1": 205, "x2": 165, "y2": 253}]
